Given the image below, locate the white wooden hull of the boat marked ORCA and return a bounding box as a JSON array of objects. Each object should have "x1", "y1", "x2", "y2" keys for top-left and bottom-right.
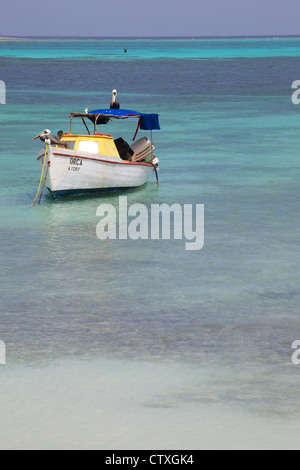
[{"x1": 38, "y1": 146, "x2": 153, "y2": 199}]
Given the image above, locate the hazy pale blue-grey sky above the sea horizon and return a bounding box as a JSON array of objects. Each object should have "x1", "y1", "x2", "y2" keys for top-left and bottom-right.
[{"x1": 0, "y1": 0, "x2": 300, "y2": 36}]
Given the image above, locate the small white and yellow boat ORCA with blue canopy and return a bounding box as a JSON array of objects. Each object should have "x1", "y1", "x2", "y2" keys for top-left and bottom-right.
[{"x1": 35, "y1": 105, "x2": 160, "y2": 199}]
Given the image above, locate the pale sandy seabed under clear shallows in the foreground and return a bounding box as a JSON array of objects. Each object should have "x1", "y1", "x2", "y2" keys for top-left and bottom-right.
[{"x1": 0, "y1": 359, "x2": 299, "y2": 450}]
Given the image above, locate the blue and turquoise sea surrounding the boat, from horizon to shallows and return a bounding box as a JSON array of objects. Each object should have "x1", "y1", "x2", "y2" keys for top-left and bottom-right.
[{"x1": 0, "y1": 38, "x2": 300, "y2": 448}]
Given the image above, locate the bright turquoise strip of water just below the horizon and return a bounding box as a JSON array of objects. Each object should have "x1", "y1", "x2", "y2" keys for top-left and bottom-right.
[{"x1": 1, "y1": 37, "x2": 300, "y2": 61}]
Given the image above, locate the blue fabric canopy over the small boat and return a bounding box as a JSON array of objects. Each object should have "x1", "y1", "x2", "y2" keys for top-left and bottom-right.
[{"x1": 89, "y1": 109, "x2": 160, "y2": 131}]
